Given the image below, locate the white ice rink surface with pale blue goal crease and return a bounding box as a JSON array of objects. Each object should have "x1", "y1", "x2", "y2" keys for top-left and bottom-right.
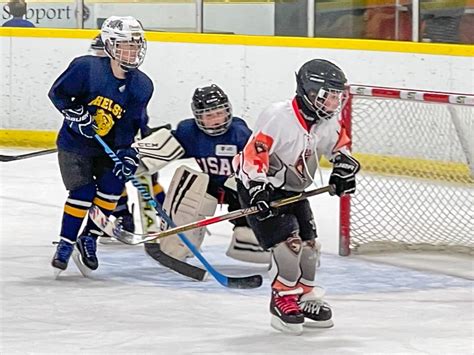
[{"x1": 0, "y1": 151, "x2": 474, "y2": 355}]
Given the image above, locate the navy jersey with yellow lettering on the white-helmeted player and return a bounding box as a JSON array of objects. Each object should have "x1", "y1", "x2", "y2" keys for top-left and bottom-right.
[{"x1": 49, "y1": 55, "x2": 153, "y2": 156}]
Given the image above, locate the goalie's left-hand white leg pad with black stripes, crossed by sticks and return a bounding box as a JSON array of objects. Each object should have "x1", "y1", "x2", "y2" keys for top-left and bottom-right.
[{"x1": 160, "y1": 166, "x2": 217, "y2": 261}]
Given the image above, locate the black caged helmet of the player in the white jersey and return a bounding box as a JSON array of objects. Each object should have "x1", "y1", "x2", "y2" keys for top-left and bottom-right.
[{"x1": 296, "y1": 59, "x2": 347, "y2": 120}]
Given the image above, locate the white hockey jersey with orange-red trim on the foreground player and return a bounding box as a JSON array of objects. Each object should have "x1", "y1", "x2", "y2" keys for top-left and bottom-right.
[{"x1": 233, "y1": 99, "x2": 350, "y2": 192}]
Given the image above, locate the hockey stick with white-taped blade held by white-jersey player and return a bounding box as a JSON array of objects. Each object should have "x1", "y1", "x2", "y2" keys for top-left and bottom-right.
[{"x1": 89, "y1": 186, "x2": 333, "y2": 245}]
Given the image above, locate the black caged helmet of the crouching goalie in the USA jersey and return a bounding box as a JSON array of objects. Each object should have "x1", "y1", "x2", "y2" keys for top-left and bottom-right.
[{"x1": 191, "y1": 84, "x2": 232, "y2": 136}]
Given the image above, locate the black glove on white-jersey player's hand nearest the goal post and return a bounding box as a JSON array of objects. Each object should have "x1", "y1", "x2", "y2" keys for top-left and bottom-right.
[{"x1": 329, "y1": 153, "x2": 360, "y2": 196}]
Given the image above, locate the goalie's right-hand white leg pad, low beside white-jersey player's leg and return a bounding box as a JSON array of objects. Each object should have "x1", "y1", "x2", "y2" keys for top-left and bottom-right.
[{"x1": 226, "y1": 226, "x2": 271, "y2": 264}]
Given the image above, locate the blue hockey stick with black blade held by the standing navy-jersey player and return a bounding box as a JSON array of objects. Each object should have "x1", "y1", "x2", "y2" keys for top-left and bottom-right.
[{"x1": 94, "y1": 134, "x2": 263, "y2": 288}]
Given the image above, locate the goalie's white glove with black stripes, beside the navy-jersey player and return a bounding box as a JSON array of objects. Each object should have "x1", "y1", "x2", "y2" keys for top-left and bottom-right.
[{"x1": 132, "y1": 128, "x2": 184, "y2": 175}]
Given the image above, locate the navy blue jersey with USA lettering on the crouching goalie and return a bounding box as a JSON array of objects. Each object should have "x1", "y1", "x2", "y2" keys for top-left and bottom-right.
[{"x1": 172, "y1": 117, "x2": 252, "y2": 186}]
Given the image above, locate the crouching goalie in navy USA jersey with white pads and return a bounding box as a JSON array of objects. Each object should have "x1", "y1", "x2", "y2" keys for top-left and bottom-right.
[{"x1": 134, "y1": 84, "x2": 270, "y2": 263}]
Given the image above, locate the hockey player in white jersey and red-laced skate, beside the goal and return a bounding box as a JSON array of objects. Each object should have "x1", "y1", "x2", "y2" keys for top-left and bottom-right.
[{"x1": 233, "y1": 59, "x2": 360, "y2": 335}]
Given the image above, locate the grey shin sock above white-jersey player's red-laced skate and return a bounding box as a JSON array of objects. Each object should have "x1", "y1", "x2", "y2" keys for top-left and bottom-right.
[{"x1": 268, "y1": 232, "x2": 303, "y2": 290}]
